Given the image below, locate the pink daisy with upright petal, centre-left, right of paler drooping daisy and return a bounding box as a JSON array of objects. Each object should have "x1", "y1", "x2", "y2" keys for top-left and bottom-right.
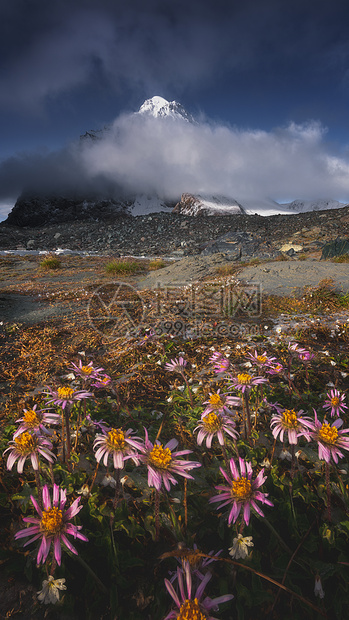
[{"x1": 138, "y1": 428, "x2": 201, "y2": 491}]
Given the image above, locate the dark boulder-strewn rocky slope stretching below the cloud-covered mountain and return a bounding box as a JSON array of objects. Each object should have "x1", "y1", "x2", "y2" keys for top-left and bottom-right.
[{"x1": 0, "y1": 206, "x2": 349, "y2": 260}]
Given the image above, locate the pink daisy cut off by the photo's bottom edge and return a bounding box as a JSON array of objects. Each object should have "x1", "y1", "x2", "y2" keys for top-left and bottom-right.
[{"x1": 165, "y1": 563, "x2": 234, "y2": 620}]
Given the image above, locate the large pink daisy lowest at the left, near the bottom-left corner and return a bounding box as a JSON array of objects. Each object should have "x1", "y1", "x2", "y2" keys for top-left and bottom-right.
[{"x1": 15, "y1": 484, "x2": 88, "y2": 566}]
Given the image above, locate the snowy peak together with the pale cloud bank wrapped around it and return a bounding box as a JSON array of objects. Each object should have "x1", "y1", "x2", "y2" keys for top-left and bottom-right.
[{"x1": 0, "y1": 97, "x2": 349, "y2": 219}]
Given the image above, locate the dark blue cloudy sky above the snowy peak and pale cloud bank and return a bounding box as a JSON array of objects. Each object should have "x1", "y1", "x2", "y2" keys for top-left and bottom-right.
[{"x1": 0, "y1": 0, "x2": 349, "y2": 211}]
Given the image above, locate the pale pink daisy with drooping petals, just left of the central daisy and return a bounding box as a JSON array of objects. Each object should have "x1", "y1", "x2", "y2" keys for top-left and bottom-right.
[{"x1": 93, "y1": 428, "x2": 143, "y2": 469}]
